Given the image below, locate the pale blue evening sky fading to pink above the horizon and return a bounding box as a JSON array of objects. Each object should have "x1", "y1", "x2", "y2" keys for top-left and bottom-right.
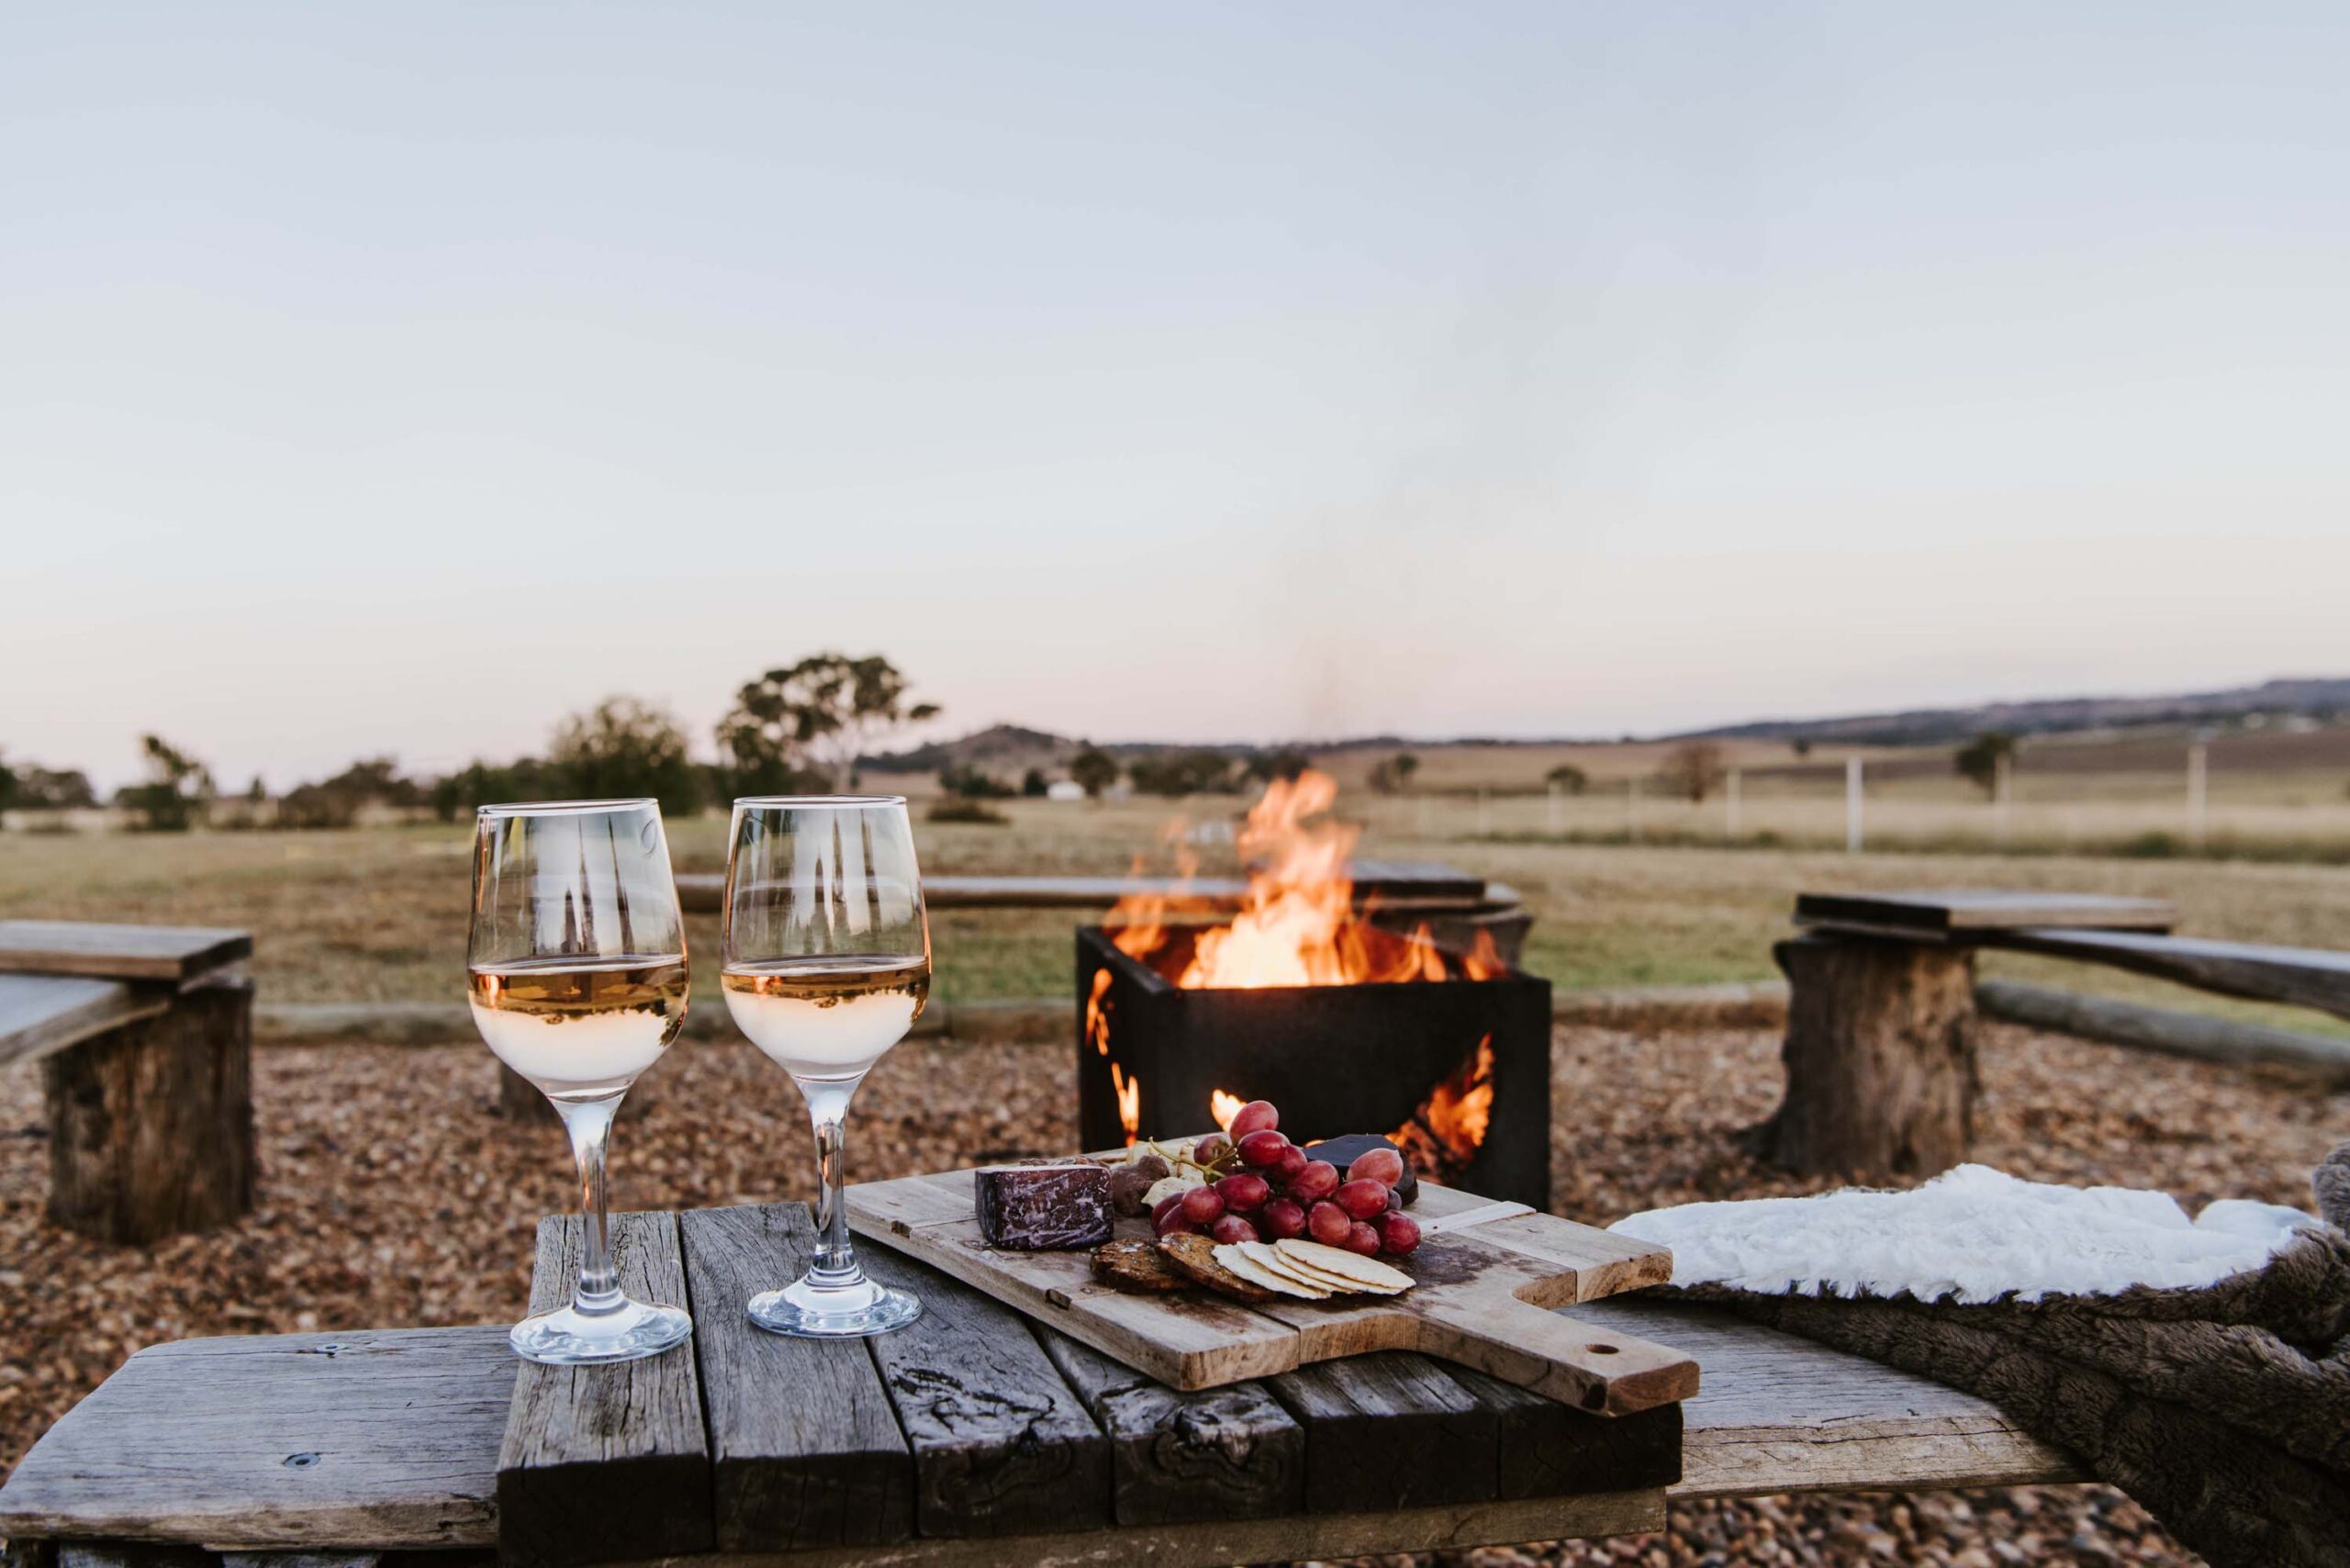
[{"x1": 0, "y1": 0, "x2": 2350, "y2": 788}]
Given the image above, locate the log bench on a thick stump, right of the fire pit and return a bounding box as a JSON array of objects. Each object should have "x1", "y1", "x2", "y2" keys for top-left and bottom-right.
[{"x1": 1753, "y1": 889, "x2": 2350, "y2": 1178}]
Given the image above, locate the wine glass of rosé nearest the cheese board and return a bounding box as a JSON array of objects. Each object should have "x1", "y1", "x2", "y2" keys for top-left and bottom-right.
[{"x1": 719, "y1": 795, "x2": 931, "y2": 1338}]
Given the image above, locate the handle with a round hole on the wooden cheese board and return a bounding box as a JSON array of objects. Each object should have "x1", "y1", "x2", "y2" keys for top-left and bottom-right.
[{"x1": 1419, "y1": 1295, "x2": 1696, "y2": 1416}]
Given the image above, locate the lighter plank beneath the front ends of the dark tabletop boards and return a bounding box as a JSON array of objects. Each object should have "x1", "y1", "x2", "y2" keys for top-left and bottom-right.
[{"x1": 588, "y1": 1490, "x2": 1663, "y2": 1568}]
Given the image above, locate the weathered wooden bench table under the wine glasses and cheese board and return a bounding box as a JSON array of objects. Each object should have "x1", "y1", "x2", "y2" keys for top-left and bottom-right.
[{"x1": 0, "y1": 1204, "x2": 2080, "y2": 1568}]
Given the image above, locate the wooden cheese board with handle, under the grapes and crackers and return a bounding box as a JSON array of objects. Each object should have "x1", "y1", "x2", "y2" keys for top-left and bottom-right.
[{"x1": 848, "y1": 1154, "x2": 1696, "y2": 1416}]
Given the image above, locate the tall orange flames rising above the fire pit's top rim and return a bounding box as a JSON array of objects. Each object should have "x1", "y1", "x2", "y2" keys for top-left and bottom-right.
[{"x1": 1109, "y1": 768, "x2": 1506, "y2": 990}]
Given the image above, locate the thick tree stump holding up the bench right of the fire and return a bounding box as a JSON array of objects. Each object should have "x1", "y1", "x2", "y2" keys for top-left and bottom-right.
[{"x1": 1758, "y1": 935, "x2": 1976, "y2": 1178}]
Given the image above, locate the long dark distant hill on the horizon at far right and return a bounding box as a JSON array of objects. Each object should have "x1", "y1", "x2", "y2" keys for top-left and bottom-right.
[{"x1": 1673, "y1": 677, "x2": 2350, "y2": 745}]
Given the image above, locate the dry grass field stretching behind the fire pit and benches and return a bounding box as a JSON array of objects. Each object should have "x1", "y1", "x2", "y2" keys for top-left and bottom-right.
[{"x1": 0, "y1": 797, "x2": 2350, "y2": 1032}]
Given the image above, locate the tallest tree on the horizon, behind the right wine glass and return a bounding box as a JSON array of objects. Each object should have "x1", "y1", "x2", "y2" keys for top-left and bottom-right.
[{"x1": 717, "y1": 654, "x2": 937, "y2": 795}]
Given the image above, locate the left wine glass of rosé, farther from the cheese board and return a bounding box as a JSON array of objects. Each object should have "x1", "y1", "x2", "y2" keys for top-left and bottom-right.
[{"x1": 465, "y1": 800, "x2": 693, "y2": 1366}]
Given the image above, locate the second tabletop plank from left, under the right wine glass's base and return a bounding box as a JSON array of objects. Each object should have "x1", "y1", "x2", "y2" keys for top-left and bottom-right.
[{"x1": 679, "y1": 1204, "x2": 914, "y2": 1551}]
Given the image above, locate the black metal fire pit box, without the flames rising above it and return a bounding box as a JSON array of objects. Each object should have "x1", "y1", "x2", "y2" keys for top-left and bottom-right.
[{"x1": 1076, "y1": 926, "x2": 1551, "y2": 1208}]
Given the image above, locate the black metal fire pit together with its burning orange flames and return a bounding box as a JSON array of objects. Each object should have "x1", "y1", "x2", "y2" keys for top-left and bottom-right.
[{"x1": 1076, "y1": 771, "x2": 1551, "y2": 1208}]
